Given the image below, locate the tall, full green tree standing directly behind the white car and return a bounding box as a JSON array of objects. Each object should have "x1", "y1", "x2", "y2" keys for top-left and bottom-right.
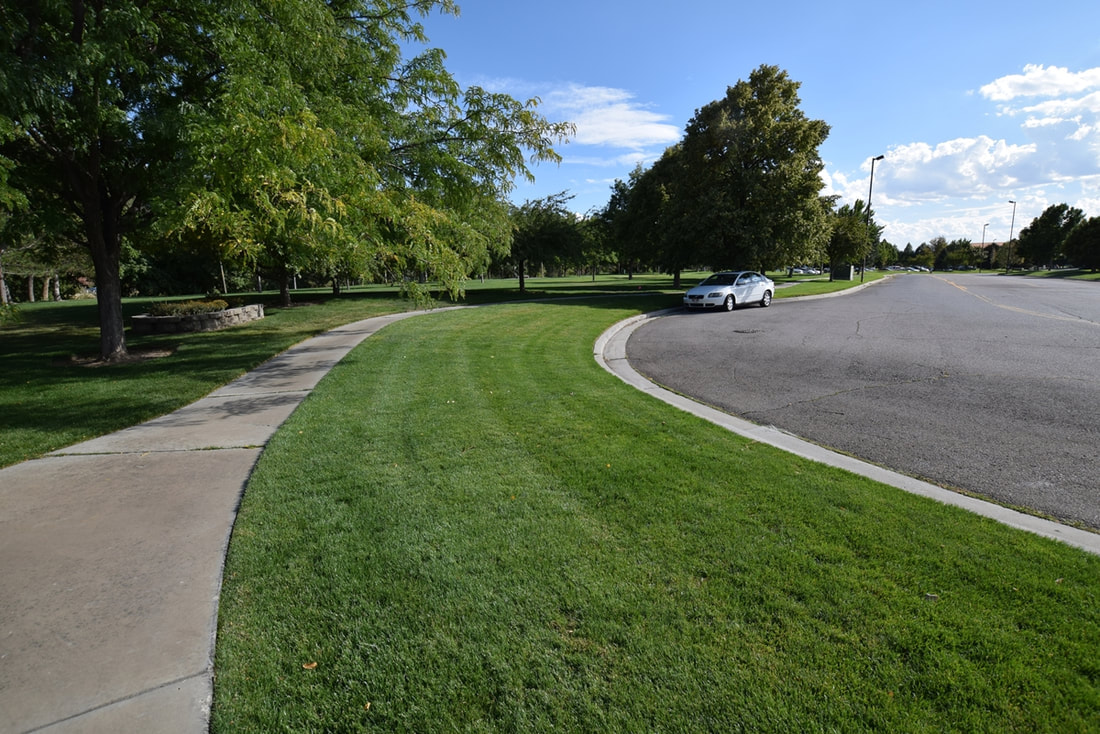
[{"x1": 677, "y1": 66, "x2": 829, "y2": 270}]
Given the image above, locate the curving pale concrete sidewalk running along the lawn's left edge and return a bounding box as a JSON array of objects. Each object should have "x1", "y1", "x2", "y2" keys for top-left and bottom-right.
[{"x1": 0, "y1": 311, "x2": 421, "y2": 734}]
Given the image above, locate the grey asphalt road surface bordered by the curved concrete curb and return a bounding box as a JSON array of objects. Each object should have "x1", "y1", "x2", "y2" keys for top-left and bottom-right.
[{"x1": 627, "y1": 273, "x2": 1100, "y2": 529}]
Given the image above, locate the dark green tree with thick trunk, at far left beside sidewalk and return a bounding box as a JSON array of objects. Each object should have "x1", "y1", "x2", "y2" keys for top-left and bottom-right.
[{"x1": 0, "y1": 0, "x2": 221, "y2": 359}]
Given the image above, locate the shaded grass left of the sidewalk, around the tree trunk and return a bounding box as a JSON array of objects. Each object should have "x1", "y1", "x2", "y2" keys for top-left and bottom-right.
[{"x1": 0, "y1": 293, "x2": 409, "y2": 465}]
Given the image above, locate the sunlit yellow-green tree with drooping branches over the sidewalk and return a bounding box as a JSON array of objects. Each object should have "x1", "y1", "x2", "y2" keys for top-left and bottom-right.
[{"x1": 174, "y1": 0, "x2": 571, "y2": 302}]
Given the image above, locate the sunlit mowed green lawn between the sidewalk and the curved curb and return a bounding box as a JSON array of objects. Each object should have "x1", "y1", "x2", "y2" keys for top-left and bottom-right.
[{"x1": 212, "y1": 297, "x2": 1100, "y2": 733}]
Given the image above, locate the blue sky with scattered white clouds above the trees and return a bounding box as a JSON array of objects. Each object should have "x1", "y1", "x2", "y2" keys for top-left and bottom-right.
[{"x1": 413, "y1": 0, "x2": 1100, "y2": 248}]
